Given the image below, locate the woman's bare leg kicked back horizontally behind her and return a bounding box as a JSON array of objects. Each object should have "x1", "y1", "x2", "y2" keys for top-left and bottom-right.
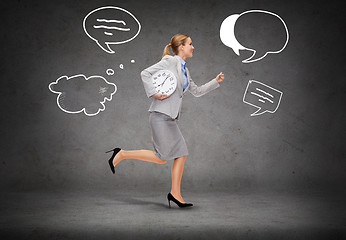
[{"x1": 113, "y1": 150, "x2": 167, "y2": 166}]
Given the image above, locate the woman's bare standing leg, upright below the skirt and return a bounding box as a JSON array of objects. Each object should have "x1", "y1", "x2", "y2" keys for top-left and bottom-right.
[{"x1": 171, "y1": 156, "x2": 186, "y2": 203}]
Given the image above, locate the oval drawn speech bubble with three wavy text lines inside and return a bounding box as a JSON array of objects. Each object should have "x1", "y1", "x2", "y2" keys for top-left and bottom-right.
[{"x1": 83, "y1": 6, "x2": 141, "y2": 53}]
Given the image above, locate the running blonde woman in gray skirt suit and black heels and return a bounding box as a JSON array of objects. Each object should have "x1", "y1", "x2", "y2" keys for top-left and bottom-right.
[{"x1": 108, "y1": 34, "x2": 224, "y2": 207}]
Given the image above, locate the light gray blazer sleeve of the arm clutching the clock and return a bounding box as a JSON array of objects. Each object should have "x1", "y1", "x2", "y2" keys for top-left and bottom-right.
[{"x1": 141, "y1": 56, "x2": 172, "y2": 98}]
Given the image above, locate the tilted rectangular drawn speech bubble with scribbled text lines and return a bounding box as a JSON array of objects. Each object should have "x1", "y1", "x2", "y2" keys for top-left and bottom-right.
[{"x1": 243, "y1": 80, "x2": 282, "y2": 116}]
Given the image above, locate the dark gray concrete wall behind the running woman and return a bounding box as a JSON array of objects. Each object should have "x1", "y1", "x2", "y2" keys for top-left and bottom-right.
[{"x1": 0, "y1": 0, "x2": 346, "y2": 190}]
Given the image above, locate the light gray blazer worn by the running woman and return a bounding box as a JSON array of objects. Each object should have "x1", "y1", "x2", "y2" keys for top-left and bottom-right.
[{"x1": 141, "y1": 55, "x2": 220, "y2": 118}]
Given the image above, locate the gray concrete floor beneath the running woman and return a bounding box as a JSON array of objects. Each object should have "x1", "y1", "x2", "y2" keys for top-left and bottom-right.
[{"x1": 0, "y1": 189, "x2": 346, "y2": 239}]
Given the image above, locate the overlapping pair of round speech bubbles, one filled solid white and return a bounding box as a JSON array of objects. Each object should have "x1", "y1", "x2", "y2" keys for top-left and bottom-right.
[{"x1": 220, "y1": 10, "x2": 289, "y2": 63}]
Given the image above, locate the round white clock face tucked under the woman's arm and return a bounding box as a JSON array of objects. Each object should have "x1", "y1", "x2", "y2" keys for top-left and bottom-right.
[{"x1": 151, "y1": 70, "x2": 177, "y2": 95}]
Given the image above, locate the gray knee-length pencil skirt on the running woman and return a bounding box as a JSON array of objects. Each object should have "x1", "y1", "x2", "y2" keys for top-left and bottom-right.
[{"x1": 149, "y1": 112, "x2": 188, "y2": 160}]
